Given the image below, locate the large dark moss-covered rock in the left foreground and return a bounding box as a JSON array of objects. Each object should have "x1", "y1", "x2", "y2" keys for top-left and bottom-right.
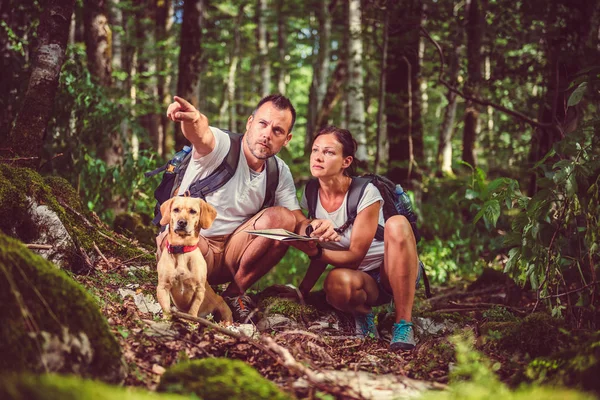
[{"x1": 0, "y1": 233, "x2": 126, "y2": 382}]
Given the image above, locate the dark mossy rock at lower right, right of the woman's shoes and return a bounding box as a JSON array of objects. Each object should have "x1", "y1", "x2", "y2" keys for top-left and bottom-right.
[{"x1": 481, "y1": 313, "x2": 564, "y2": 357}]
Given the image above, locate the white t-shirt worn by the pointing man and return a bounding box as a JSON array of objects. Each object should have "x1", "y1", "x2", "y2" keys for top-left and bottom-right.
[{"x1": 177, "y1": 127, "x2": 300, "y2": 237}]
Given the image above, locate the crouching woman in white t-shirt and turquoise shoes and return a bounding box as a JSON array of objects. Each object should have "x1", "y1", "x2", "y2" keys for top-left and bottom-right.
[{"x1": 294, "y1": 126, "x2": 418, "y2": 350}]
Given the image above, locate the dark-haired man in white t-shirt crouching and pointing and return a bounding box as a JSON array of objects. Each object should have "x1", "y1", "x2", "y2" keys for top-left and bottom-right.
[{"x1": 157, "y1": 95, "x2": 304, "y2": 322}]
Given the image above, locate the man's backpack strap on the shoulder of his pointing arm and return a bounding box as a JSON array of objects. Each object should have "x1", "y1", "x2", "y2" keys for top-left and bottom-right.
[{"x1": 189, "y1": 131, "x2": 243, "y2": 199}]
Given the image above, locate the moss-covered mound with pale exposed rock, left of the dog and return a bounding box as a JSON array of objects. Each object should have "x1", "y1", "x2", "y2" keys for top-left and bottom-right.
[{"x1": 0, "y1": 164, "x2": 155, "y2": 272}]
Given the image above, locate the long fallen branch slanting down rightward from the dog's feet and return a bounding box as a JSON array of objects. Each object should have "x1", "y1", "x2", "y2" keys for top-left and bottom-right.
[{"x1": 171, "y1": 311, "x2": 361, "y2": 399}]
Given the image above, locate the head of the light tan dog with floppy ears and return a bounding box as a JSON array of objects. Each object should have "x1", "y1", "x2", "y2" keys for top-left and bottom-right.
[{"x1": 160, "y1": 196, "x2": 217, "y2": 239}]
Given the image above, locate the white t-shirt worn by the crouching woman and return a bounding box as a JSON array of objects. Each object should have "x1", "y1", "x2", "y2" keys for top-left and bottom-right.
[{"x1": 300, "y1": 183, "x2": 385, "y2": 271}]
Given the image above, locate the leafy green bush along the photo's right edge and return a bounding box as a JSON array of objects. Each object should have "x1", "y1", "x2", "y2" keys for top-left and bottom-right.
[{"x1": 472, "y1": 120, "x2": 600, "y2": 322}]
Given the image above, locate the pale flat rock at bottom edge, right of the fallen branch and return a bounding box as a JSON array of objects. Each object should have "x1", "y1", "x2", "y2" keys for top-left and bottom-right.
[{"x1": 294, "y1": 370, "x2": 443, "y2": 400}]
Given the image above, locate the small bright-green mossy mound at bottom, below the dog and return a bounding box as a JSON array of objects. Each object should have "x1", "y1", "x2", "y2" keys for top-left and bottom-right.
[{"x1": 157, "y1": 358, "x2": 291, "y2": 400}]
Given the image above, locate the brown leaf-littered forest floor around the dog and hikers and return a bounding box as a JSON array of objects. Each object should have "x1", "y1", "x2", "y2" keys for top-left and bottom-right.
[{"x1": 75, "y1": 248, "x2": 535, "y2": 398}]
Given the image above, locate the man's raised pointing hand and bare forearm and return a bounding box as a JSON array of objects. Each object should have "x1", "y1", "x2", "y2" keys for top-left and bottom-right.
[{"x1": 167, "y1": 96, "x2": 215, "y2": 156}]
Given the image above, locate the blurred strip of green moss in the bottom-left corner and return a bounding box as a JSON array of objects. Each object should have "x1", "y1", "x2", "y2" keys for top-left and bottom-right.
[{"x1": 0, "y1": 374, "x2": 189, "y2": 400}]
